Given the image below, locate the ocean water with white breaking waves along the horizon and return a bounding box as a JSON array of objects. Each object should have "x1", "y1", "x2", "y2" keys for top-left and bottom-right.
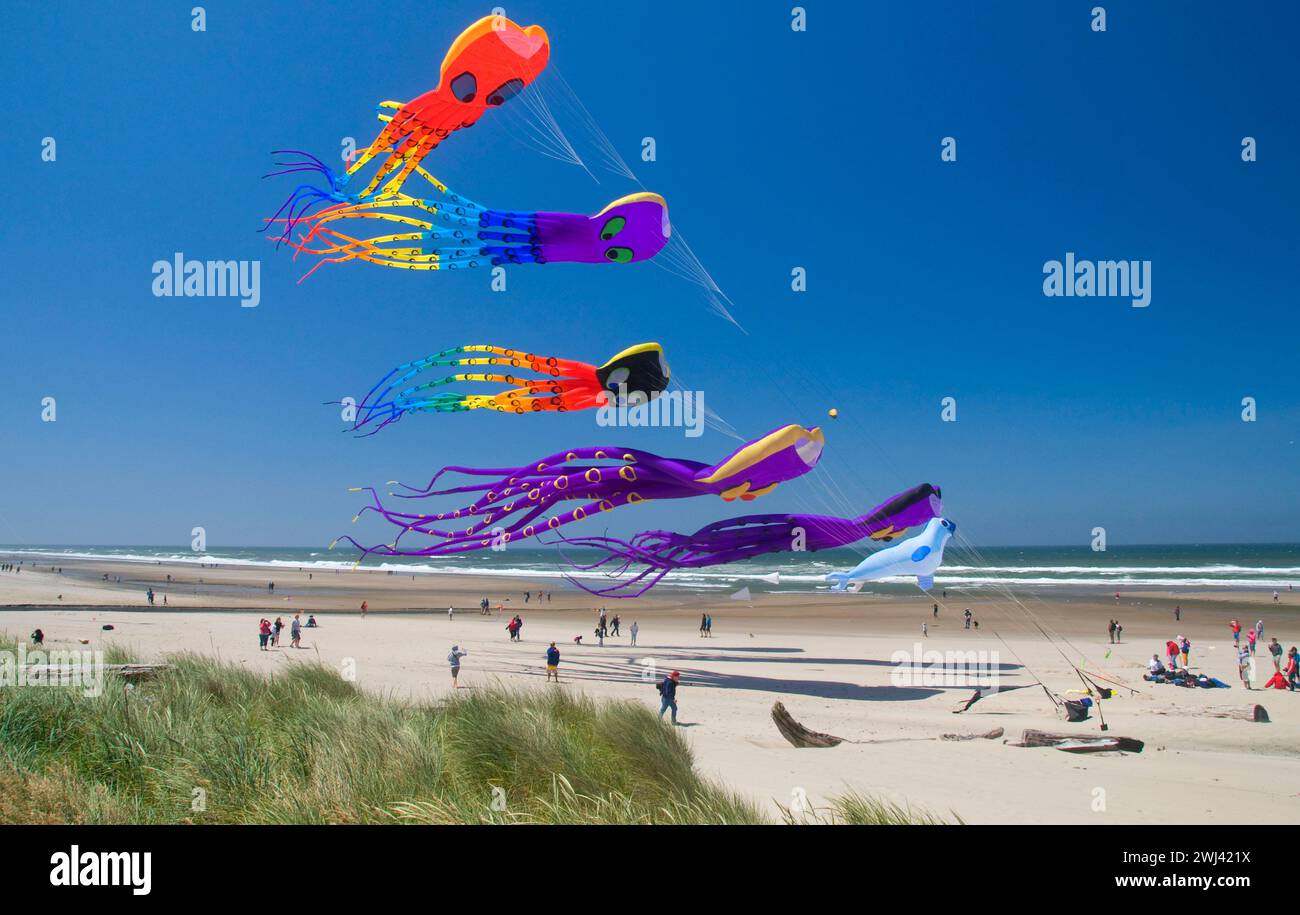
[{"x1": 0, "y1": 543, "x2": 1300, "y2": 593}]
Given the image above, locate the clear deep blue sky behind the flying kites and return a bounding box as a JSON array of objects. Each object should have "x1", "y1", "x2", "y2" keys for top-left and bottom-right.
[{"x1": 0, "y1": 0, "x2": 1300, "y2": 547}]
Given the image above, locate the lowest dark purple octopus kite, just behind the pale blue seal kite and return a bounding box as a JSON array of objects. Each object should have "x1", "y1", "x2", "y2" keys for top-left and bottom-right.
[{"x1": 564, "y1": 483, "x2": 943, "y2": 598}]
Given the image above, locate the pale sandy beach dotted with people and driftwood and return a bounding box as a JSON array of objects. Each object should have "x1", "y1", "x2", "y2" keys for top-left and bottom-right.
[{"x1": 0, "y1": 558, "x2": 1300, "y2": 823}]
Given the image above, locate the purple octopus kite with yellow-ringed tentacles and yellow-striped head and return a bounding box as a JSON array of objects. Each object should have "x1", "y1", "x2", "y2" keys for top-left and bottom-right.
[{"x1": 330, "y1": 425, "x2": 826, "y2": 561}]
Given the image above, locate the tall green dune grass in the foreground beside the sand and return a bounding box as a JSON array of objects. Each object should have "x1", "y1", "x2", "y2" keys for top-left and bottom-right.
[{"x1": 0, "y1": 638, "x2": 956, "y2": 824}]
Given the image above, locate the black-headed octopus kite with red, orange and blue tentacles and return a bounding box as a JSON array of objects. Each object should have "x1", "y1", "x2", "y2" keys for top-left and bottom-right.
[{"x1": 352, "y1": 343, "x2": 668, "y2": 435}]
